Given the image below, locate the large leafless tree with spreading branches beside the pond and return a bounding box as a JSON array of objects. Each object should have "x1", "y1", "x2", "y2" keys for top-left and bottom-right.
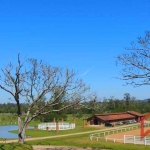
[{"x1": 0, "y1": 54, "x2": 92, "y2": 143}]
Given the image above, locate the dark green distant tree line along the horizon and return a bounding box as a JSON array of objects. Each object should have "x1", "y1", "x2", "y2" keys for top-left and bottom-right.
[{"x1": 0, "y1": 93, "x2": 150, "y2": 118}]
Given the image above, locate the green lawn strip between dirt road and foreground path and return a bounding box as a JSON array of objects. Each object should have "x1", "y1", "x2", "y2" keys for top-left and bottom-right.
[{"x1": 27, "y1": 134, "x2": 149, "y2": 150}]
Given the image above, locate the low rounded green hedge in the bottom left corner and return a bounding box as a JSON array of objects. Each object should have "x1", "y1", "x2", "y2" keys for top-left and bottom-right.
[{"x1": 0, "y1": 143, "x2": 33, "y2": 150}]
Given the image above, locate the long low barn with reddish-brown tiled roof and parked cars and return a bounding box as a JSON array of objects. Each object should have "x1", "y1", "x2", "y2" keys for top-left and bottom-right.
[{"x1": 87, "y1": 111, "x2": 144, "y2": 125}]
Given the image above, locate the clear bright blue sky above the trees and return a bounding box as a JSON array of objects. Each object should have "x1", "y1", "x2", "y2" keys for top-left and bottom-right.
[{"x1": 0, "y1": 0, "x2": 150, "y2": 103}]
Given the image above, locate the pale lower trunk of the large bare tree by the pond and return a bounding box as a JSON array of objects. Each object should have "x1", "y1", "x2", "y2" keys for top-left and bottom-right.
[{"x1": 18, "y1": 116, "x2": 26, "y2": 144}]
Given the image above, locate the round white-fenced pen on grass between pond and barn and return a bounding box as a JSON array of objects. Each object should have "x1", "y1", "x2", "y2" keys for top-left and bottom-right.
[{"x1": 38, "y1": 122, "x2": 75, "y2": 130}]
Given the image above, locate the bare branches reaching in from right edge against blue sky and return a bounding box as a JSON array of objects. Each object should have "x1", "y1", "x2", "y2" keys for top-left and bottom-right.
[{"x1": 117, "y1": 31, "x2": 150, "y2": 87}]
